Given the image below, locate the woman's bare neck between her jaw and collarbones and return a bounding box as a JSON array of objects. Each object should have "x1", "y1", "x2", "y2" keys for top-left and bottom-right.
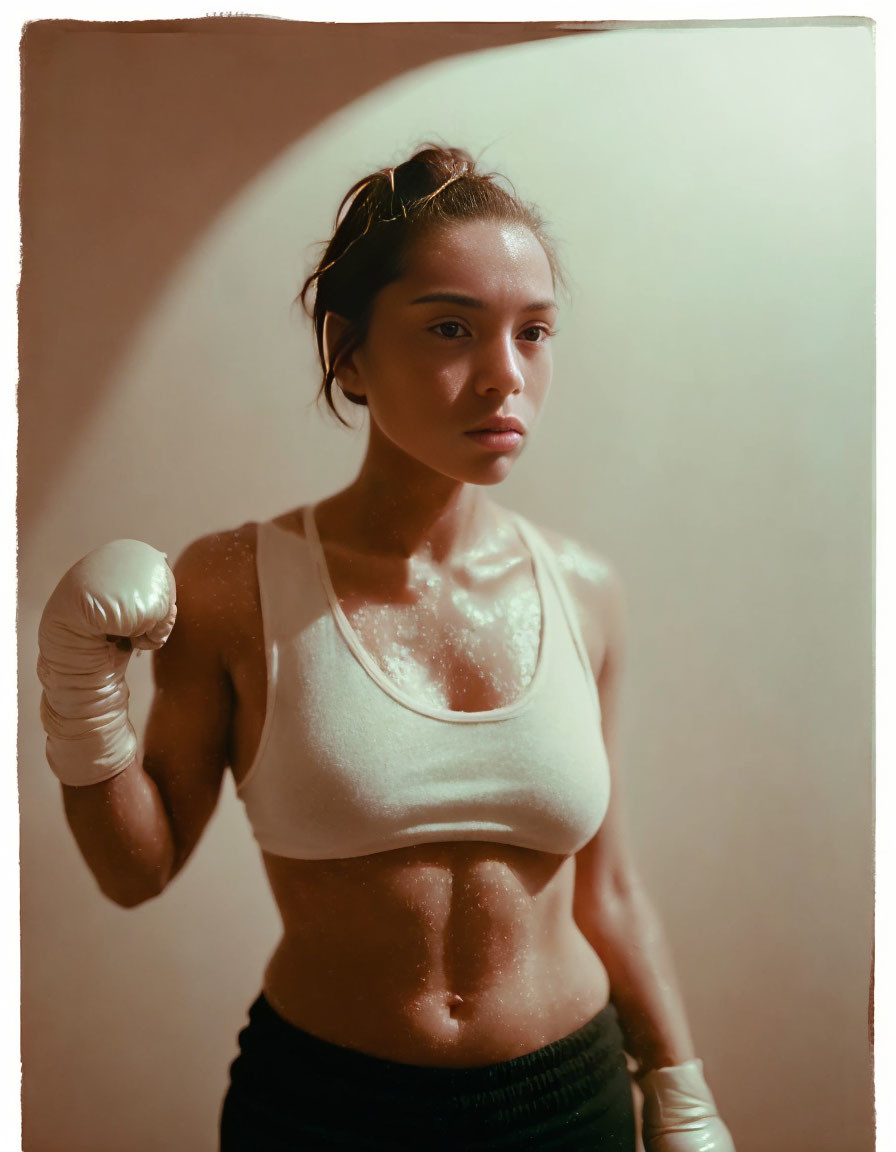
[{"x1": 318, "y1": 433, "x2": 494, "y2": 562}]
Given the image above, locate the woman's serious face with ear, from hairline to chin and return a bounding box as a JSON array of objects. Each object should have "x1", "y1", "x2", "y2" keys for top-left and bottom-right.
[{"x1": 340, "y1": 220, "x2": 556, "y2": 484}]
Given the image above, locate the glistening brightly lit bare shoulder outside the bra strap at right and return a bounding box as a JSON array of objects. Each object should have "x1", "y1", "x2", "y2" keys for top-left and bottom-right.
[{"x1": 522, "y1": 526, "x2": 627, "y2": 676}]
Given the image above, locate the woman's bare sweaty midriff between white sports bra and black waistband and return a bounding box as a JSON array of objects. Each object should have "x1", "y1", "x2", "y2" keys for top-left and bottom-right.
[{"x1": 256, "y1": 842, "x2": 609, "y2": 1067}]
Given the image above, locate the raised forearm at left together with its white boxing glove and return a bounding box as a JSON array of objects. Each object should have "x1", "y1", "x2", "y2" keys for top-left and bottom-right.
[{"x1": 37, "y1": 540, "x2": 176, "y2": 905}]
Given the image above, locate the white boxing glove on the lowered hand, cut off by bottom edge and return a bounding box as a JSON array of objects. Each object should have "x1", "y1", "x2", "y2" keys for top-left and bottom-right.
[{"x1": 638, "y1": 1060, "x2": 735, "y2": 1152}]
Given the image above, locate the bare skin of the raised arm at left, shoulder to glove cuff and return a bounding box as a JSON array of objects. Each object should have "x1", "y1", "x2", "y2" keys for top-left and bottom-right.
[{"x1": 54, "y1": 533, "x2": 239, "y2": 908}]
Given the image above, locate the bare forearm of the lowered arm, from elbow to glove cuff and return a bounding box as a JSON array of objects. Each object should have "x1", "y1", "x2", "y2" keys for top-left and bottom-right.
[{"x1": 576, "y1": 881, "x2": 694, "y2": 1073}]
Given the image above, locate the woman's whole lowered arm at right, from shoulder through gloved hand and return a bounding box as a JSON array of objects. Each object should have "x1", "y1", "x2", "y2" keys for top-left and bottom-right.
[{"x1": 557, "y1": 546, "x2": 734, "y2": 1152}]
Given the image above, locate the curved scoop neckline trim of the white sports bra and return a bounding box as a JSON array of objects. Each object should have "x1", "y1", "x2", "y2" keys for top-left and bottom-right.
[{"x1": 302, "y1": 505, "x2": 548, "y2": 723}]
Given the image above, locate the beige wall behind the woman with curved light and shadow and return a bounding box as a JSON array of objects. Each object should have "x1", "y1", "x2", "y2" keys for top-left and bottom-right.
[{"x1": 20, "y1": 15, "x2": 874, "y2": 1152}]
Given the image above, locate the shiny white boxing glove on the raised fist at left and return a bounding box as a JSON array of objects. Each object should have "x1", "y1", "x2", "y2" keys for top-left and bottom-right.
[{"x1": 37, "y1": 540, "x2": 177, "y2": 786}]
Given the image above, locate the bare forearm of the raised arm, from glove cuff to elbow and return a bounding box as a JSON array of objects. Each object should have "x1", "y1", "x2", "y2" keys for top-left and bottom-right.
[{"x1": 62, "y1": 760, "x2": 177, "y2": 908}]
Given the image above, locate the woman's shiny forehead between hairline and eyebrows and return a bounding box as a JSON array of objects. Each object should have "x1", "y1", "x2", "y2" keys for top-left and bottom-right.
[{"x1": 396, "y1": 220, "x2": 554, "y2": 300}]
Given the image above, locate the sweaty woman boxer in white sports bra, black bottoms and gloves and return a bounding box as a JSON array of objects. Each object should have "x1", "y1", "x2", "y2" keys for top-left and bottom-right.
[{"x1": 39, "y1": 146, "x2": 732, "y2": 1152}]
